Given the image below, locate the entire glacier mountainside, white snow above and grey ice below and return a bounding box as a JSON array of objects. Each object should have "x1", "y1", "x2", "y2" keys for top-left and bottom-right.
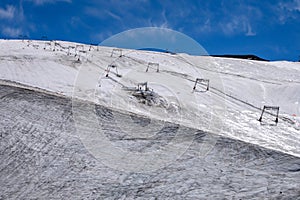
[{"x1": 0, "y1": 40, "x2": 300, "y2": 198}]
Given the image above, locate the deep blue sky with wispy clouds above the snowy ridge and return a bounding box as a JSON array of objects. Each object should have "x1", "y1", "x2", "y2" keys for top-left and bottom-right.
[{"x1": 0, "y1": 0, "x2": 300, "y2": 61}]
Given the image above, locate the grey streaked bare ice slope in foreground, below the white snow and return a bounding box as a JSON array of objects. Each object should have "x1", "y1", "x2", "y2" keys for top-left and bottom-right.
[{"x1": 0, "y1": 85, "x2": 300, "y2": 200}]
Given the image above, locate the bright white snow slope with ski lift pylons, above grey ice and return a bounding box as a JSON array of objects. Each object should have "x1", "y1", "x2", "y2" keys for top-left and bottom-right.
[{"x1": 0, "y1": 40, "x2": 300, "y2": 156}]
